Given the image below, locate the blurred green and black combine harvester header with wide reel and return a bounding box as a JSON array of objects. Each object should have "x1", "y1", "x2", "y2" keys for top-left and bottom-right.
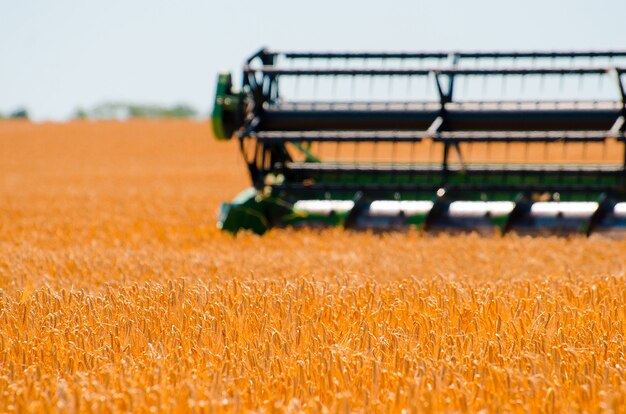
[{"x1": 212, "y1": 49, "x2": 626, "y2": 234}]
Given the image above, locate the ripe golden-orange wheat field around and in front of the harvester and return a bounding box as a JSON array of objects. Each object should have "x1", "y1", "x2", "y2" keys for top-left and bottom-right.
[{"x1": 0, "y1": 122, "x2": 626, "y2": 412}]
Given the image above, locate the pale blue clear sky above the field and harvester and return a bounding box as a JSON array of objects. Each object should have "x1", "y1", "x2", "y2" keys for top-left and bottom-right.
[{"x1": 0, "y1": 0, "x2": 626, "y2": 120}]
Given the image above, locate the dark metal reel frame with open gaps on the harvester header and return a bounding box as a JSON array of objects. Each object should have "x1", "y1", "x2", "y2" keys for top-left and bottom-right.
[{"x1": 216, "y1": 49, "x2": 626, "y2": 232}]
